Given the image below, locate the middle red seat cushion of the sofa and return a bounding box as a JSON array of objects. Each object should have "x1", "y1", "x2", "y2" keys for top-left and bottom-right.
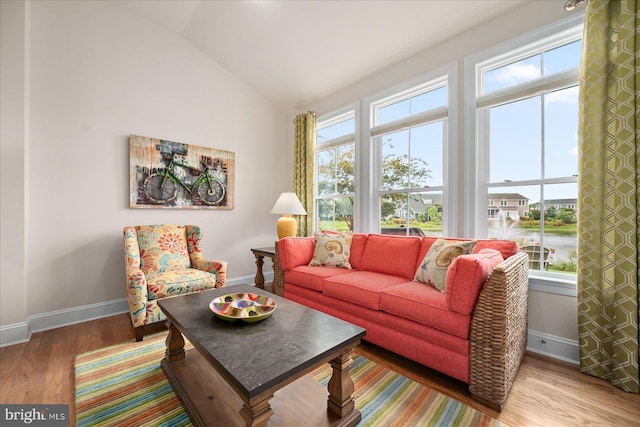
[{"x1": 322, "y1": 271, "x2": 406, "y2": 310}]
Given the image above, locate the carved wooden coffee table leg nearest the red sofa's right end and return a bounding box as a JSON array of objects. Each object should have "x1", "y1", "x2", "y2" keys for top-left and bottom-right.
[{"x1": 327, "y1": 348, "x2": 361, "y2": 425}]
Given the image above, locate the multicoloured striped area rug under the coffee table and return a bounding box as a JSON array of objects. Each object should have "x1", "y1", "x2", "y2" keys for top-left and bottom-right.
[{"x1": 75, "y1": 333, "x2": 504, "y2": 427}]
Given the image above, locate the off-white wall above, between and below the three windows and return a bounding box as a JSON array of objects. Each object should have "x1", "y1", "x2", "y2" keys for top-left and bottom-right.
[{"x1": 300, "y1": 1, "x2": 578, "y2": 361}]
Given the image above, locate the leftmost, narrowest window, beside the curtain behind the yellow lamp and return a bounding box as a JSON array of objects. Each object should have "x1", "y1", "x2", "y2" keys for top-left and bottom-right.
[{"x1": 314, "y1": 110, "x2": 356, "y2": 231}]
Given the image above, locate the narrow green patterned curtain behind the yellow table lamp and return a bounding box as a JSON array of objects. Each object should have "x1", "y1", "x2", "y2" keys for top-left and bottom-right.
[{"x1": 293, "y1": 111, "x2": 316, "y2": 236}]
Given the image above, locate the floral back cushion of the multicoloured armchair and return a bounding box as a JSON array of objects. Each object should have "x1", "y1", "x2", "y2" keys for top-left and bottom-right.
[{"x1": 136, "y1": 224, "x2": 191, "y2": 275}]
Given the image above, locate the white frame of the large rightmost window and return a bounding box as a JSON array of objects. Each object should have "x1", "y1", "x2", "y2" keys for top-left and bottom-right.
[{"x1": 463, "y1": 11, "x2": 584, "y2": 296}]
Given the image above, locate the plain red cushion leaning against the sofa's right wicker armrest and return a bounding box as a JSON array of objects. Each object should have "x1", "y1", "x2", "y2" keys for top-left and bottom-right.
[{"x1": 447, "y1": 249, "x2": 503, "y2": 314}]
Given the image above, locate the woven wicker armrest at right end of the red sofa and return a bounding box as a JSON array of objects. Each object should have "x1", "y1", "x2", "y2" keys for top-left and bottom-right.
[{"x1": 469, "y1": 252, "x2": 529, "y2": 410}]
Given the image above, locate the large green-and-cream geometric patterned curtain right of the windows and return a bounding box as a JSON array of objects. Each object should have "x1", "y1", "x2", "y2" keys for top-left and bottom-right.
[{"x1": 578, "y1": 0, "x2": 640, "y2": 393}]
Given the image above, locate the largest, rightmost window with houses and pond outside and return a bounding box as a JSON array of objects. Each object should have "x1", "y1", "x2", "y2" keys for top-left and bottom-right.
[{"x1": 466, "y1": 17, "x2": 582, "y2": 286}]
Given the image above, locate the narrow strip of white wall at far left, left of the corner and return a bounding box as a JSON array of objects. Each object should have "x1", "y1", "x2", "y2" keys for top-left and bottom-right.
[{"x1": 0, "y1": 1, "x2": 29, "y2": 335}]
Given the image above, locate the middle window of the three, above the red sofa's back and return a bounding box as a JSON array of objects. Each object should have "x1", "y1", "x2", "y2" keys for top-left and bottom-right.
[{"x1": 370, "y1": 75, "x2": 450, "y2": 241}]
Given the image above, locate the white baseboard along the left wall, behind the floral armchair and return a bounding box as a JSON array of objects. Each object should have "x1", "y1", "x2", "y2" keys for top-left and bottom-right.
[{"x1": 0, "y1": 271, "x2": 273, "y2": 347}]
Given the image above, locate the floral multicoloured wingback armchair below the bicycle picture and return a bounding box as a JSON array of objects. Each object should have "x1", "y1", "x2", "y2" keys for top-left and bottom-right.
[{"x1": 123, "y1": 224, "x2": 227, "y2": 341}]
